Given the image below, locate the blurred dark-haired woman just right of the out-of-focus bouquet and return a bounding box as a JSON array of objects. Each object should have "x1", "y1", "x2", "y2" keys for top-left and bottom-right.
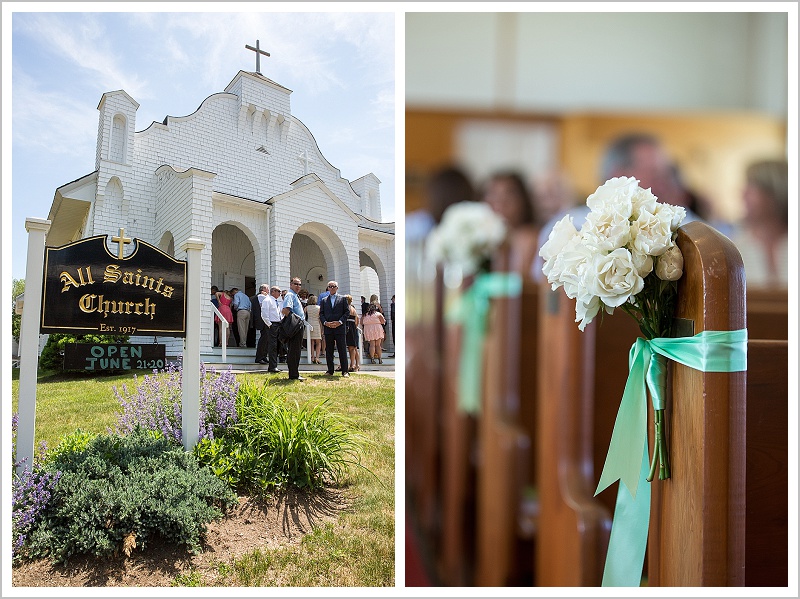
[{"x1": 483, "y1": 171, "x2": 538, "y2": 275}]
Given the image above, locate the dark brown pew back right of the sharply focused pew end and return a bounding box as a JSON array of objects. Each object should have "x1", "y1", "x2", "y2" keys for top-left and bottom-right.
[{"x1": 745, "y1": 340, "x2": 789, "y2": 587}]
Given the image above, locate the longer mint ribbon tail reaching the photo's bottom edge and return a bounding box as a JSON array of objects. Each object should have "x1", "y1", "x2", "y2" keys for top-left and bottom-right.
[{"x1": 603, "y1": 443, "x2": 650, "y2": 587}]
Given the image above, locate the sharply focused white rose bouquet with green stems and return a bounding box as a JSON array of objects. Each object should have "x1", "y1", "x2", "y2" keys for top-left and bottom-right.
[{"x1": 539, "y1": 177, "x2": 686, "y2": 480}]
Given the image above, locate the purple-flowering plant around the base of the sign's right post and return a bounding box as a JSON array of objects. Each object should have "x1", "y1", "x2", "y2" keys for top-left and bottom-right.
[{"x1": 113, "y1": 363, "x2": 239, "y2": 443}]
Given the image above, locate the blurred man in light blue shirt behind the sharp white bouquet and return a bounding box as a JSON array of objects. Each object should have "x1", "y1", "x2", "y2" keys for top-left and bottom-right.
[{"x1": 532, "y1": 133, "x2": 698, "y2": 281}]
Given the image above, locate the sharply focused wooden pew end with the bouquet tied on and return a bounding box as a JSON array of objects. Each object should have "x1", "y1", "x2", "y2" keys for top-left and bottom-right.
[{"x1": 647, "y1": 222, "x2": 746, "y2": 586}]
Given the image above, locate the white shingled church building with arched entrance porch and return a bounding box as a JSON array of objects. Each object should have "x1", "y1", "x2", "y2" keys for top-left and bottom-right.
[{"x1": 46, "y1": 68, "x2": 395, "y2": 355}]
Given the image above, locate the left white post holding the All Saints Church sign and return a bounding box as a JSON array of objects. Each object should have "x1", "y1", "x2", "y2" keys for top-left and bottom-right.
[{"x1": 16, "y1": 218, "x2": 51, "y2": 471}]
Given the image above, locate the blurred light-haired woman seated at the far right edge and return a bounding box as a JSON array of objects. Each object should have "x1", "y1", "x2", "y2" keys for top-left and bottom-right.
[{"x1": 731, "y1": 160, "x2": 789, "y2": 288}]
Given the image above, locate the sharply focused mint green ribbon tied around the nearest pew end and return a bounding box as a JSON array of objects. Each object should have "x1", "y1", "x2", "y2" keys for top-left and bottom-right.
[{"x1": 595, "y1": 329, "x2": 747, "y2": 587}]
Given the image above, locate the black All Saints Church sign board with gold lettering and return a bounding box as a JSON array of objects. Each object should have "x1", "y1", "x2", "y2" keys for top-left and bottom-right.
[{"x1": 40, "y1": 229, "x2": 186, "y2": 337}]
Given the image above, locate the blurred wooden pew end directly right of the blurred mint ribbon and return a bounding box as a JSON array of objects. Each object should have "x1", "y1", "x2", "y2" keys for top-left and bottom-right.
[{"x1": 474, "y1": 247, "x2": 538, "y2": 586}]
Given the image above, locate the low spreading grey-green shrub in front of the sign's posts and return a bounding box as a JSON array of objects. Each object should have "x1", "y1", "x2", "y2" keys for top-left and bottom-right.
[{"x1": 27, "y1": 427, "x2": 236, "y2": 563}]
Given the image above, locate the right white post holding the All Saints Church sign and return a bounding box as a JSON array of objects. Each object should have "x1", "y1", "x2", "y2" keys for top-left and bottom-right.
[{"x1": 181, "y1": 237, "x2": 205, "y2": 451}]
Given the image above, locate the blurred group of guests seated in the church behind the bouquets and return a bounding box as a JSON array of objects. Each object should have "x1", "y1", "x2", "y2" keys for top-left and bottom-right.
[{"x1": 416, "y1": 132, "x2": 788, "y2": 287}]
